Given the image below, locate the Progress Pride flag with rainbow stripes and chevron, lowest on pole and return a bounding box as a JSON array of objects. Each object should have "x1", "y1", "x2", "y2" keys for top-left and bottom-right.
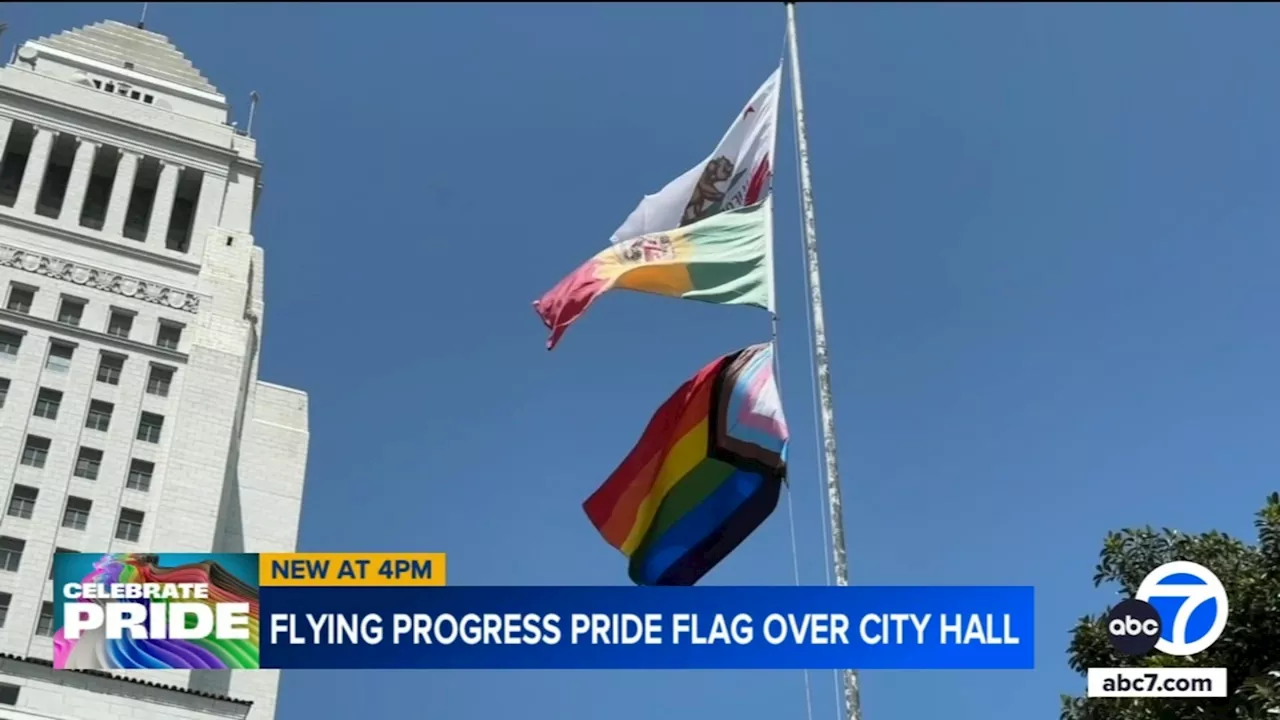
[{"x1": 582, "y1": 345, "x2": 788, "y2": 585}]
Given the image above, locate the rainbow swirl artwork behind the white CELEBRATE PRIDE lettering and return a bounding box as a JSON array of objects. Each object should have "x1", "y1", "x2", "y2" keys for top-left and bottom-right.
[{"x1": 54, "y1": 553, "x2": 259, "y2": 670}]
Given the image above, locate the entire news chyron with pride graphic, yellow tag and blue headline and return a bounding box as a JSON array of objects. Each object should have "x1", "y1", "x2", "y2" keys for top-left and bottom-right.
[{"x1": 54, "y1": 553, "x2": 1036, "y2": 670}]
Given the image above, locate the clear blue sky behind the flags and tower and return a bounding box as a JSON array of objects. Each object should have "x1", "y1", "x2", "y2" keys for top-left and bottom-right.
[{"x1": 5, "y1": 3, "x2": 1280, "y2": 720}]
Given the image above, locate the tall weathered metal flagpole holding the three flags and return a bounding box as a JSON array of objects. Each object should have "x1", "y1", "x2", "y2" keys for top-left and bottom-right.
[{"x1": 786, "y1": 3, "x2": 863, "y2": 720}]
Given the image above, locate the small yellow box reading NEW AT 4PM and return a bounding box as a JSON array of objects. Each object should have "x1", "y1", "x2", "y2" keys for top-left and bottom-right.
[{"x1": 257, "y1": 552, "x2": 445, "y2": 588}]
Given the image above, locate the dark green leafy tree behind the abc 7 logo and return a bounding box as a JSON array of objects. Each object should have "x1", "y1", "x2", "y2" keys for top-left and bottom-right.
[{"x1": 1061, "y1": 493, "x2": 1280, "y2": 720}]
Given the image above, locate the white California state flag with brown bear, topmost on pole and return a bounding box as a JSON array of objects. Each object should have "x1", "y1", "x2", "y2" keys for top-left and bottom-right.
[{"x1": 609, "y1": 67, "x2": 782, "y2": 242}]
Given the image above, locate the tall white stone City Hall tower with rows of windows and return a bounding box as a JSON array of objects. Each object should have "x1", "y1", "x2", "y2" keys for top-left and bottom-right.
[{"x1": 0, "y1": 22, "x2": 308, "y2": 720}]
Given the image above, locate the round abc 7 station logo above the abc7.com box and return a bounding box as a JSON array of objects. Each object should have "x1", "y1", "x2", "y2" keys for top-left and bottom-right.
[{"x1": 1107, "y1": 561, "x2": 1228, "y2": 656}]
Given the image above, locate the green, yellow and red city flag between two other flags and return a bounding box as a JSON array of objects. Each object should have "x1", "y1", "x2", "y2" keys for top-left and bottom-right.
[{"x1": 534, "y1": 197, "x2": 773, "y2": 350}]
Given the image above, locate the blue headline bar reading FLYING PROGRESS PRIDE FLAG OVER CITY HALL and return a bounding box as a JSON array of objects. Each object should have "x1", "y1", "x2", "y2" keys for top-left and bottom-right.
[{"x1": 259, "y1": 587, "x2": 1036, "y2": 670}]
